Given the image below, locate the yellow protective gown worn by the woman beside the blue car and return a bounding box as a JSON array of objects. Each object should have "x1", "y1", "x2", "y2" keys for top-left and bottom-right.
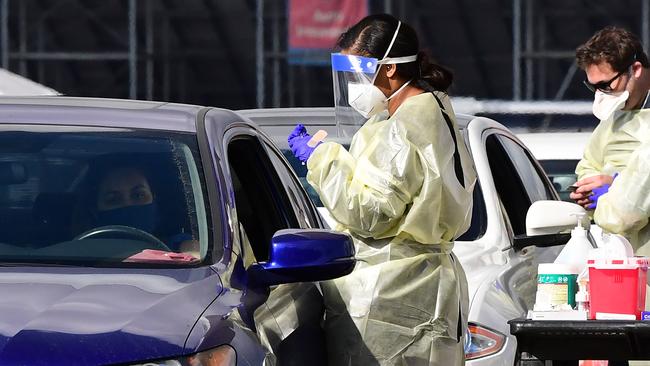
[{"x1": 307, "y1": 93, "x2": 476, "y2": 365}]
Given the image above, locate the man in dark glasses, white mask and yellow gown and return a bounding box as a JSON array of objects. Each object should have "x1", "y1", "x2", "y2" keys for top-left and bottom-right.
[{"x1": 571, "y1": 27, "x2": 650, "y2": 255}]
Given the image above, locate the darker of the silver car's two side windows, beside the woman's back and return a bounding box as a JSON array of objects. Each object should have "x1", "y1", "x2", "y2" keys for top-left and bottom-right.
[{"x1": 485, "y1": 134, "x2": 539, "y2": 235}]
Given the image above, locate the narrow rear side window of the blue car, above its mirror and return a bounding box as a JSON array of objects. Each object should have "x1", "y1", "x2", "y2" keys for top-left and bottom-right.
[{"x1": 264, "y1": 142, "x2": 320, "y2": 228}]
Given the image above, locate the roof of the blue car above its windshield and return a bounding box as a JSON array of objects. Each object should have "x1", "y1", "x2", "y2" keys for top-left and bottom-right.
[{"x1": 0, "y1": 96, "x2": 204, "y2": 132}]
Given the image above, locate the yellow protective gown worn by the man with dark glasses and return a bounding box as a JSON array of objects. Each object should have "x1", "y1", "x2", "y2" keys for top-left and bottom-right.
[{"x1": 576, "y1": 103, "x2": 650, "y2": 365}]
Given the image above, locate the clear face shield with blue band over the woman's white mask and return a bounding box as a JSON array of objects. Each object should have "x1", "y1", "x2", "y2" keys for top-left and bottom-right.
[{"x1": 332, "y1": 22, "x2": 417, "y2": 130}]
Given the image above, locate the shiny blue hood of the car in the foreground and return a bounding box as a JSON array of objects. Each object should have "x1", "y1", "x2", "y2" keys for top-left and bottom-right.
[{"x1": 0, "y1": 267, "x2": 222, "y2": 365}]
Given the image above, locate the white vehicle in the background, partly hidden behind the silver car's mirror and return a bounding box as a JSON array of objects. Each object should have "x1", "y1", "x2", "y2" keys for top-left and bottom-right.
[{"x1": 517, "y1": 132, "x2": 591, "y2": 202}]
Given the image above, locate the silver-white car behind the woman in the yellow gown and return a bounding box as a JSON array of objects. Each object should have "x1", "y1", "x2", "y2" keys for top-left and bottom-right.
[{"x1": 239, "y1": 108, "x2": 561, "y2": 366}]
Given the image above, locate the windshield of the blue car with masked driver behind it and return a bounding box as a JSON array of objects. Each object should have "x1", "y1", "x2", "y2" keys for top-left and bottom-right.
[{"x1": 0, "y1": 125, "x2": 209, "y2": 266}]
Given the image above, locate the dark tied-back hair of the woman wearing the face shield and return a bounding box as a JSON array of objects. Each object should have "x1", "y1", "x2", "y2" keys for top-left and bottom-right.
[{"x1": 337, "y1": 14, "x2": 453, "y2": 92}]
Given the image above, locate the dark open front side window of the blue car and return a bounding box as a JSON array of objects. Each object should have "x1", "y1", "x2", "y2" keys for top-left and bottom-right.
[{"x1": 228, "y1": 135, "x2": 299, "y2": 261}]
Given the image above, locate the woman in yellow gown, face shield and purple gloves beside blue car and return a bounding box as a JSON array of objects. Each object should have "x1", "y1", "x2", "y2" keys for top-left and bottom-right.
[{"x1": 289, "y1": 15, "x2": 476, "y2": 365}]
